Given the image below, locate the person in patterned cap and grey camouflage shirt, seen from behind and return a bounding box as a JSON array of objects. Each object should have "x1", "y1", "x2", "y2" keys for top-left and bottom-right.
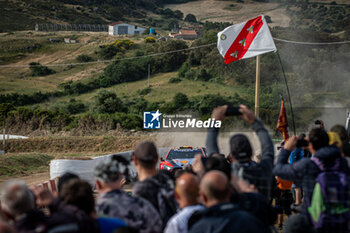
[{"x1": 94, "y1": 157, "x2": 162, "y2": 233}]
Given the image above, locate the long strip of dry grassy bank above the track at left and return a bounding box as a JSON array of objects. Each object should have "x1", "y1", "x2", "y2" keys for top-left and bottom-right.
[{"x1": 6, "y1": 135, "x2": 152, "y2": 153}]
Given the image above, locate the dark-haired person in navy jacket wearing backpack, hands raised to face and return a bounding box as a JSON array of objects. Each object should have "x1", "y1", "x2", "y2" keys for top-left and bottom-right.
[{"x1": 273, "y1": 128, "x2": 349, "y2": 232}]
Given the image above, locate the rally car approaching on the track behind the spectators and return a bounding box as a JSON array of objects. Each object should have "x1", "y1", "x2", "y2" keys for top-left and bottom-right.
[{"x1": 160, "y1": 146, "x2": 206, "y2": 172}]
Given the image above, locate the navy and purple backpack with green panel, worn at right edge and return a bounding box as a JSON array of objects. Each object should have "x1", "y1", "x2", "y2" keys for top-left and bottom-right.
[{"x1": 308, "y1": 157, "x2": 350, "y2": 232}]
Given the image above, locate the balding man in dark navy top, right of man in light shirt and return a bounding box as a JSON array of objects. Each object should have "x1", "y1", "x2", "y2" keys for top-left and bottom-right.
[{"x1": 189, "y1": 171, "x2": 269, "y2": 233}]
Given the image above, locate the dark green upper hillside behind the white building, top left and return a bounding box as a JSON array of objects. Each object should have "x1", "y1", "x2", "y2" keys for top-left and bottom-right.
[{"x1": 0, "y1": 0, "x2": 197, "y2": 32}]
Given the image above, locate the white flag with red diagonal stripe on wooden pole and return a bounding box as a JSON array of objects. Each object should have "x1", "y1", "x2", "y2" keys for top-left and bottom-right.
[{"x1": 217, "y1": 15, "x2": 277, "y2": 64}]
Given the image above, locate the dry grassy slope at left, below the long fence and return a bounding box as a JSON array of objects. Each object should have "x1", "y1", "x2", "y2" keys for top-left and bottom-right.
[{"x1": 0, "y1": 31, "x2": 143, "y2": 94}]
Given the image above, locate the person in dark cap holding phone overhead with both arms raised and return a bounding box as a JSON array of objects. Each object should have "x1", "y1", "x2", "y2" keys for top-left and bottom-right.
[{"x1": 206, "y1": 105, "x2": 274, "y2": 198}]
